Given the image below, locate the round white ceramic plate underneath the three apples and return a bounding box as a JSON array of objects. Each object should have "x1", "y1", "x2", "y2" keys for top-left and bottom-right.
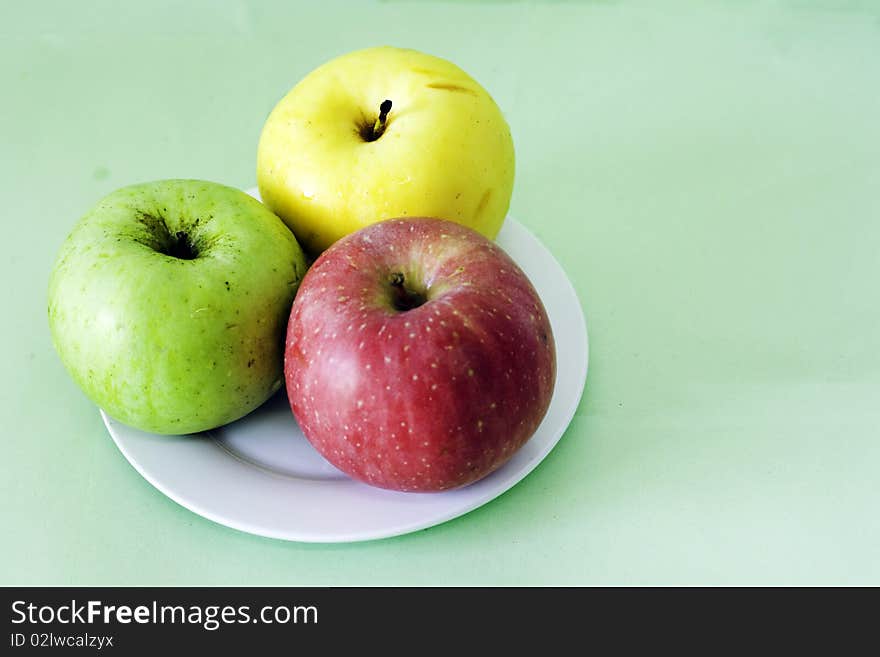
[{"x1": 101, "y1": 190, "x2": 587, "y2": 543}]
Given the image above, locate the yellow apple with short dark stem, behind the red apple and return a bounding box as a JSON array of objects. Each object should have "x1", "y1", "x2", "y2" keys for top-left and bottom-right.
[{"x1": 257, "y1": 47, "x2": 514, "y2": 254}]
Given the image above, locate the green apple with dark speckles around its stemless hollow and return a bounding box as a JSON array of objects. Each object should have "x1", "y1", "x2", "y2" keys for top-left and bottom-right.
[{"x1": 49, "y1": 180, "x2": 306, "y2": 434}]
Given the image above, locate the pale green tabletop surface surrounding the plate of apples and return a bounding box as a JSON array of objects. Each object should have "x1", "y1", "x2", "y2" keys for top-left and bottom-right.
[{"x1": 0, "y1": 0, "x2": 880, "y2": 585}]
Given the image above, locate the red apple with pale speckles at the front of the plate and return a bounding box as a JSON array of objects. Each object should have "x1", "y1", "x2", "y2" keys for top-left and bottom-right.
[{"x1": 284, "y1": 218, "x2": 556, "y2": 492}]
